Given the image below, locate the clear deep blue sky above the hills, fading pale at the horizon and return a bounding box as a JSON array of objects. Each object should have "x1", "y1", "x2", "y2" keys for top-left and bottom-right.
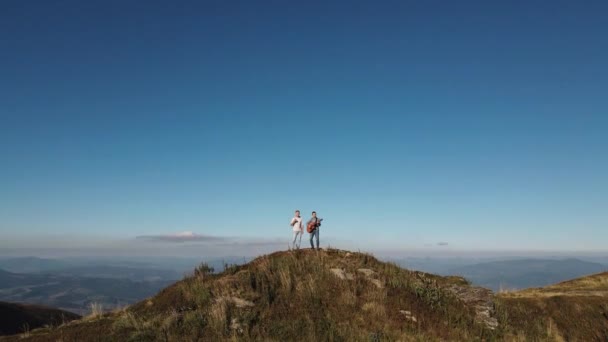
[{"x1": 0, "y1": 1, "x2": 608, "y2": 251}]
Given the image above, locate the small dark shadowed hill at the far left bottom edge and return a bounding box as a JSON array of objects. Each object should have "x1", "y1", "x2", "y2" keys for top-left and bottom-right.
[{"x1": 0, "y1": 302, "x2": 80, "y2": 335}]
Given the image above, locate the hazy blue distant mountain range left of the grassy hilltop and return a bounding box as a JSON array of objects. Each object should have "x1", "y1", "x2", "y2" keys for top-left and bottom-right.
[{"x1": 0, "y1": 257, "x2": 253, "y2": 315}]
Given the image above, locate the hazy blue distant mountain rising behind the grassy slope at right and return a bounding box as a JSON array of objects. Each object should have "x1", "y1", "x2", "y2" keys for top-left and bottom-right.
[{"x1": 446, "y1": 259, "x2": 608, "y2": 291}]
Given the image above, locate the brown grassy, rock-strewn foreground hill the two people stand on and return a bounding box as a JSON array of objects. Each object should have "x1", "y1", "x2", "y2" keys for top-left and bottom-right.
[{"x1": 4, "y1": 249, "x2": 608, "y2": 342}]
